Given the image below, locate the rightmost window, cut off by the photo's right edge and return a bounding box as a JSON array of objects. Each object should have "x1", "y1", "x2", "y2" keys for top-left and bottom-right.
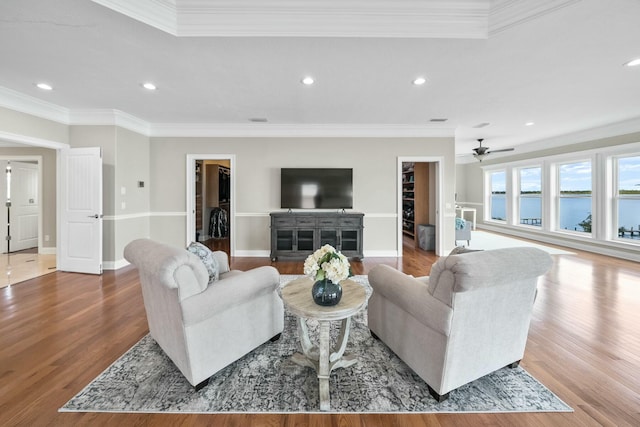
[{"x1": 614, "y1": 156, "x2": 640, "y2": 240}]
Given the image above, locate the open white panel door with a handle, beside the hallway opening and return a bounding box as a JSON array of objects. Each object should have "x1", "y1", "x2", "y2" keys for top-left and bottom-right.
[{"x1": 57, "y1": 147, "x2": 102, "y2": 274}]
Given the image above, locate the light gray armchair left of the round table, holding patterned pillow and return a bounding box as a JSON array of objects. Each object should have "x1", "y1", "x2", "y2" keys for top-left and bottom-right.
[{"x1": 124, "y1": 239, "x2": 284, "y2": 389}]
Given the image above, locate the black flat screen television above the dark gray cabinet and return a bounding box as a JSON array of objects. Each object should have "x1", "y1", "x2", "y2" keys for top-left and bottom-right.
[{"x1": 280, "y1": 168, "x2": 353, "y2": 209}]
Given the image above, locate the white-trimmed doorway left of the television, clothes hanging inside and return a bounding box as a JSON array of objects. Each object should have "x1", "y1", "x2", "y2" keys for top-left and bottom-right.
[{"x1": 186, "y1": 154, "x2": 235, "y2": 256}]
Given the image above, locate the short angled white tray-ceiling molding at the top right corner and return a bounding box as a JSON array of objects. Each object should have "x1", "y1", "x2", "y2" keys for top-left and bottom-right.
[{"x1": 489, "y1": 0, "x2": 581, "y2": 36}]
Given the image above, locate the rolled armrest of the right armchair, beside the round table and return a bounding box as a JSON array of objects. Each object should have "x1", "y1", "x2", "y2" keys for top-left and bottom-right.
[{"x1": 369, "y1": 265, "x2": 453, "y2": 335}]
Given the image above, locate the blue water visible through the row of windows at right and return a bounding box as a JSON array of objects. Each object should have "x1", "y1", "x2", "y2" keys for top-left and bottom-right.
[{"x1": 491, "y1": 195, "x2": 640, "y2": 238}]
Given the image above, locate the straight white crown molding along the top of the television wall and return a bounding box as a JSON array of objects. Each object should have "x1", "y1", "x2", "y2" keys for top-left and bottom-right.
[{"x1": 149, "y1": 123, "x2": 455, "y2": 138}]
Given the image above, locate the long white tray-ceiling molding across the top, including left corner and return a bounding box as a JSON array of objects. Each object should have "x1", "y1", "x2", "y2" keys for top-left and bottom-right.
[{"x1": 93, "y1": 0, "x2": 490, "y2": 38}]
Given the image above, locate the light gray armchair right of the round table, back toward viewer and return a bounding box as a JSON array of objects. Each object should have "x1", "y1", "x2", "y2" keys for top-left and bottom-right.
[{"x1": 368, "y1": 247, "x2": 551, "y2": 401}]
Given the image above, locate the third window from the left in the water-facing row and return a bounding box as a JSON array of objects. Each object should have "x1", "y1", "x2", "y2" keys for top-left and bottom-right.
[{"x1": 557, "y1": 161, "x2": 592, "y2": 233}]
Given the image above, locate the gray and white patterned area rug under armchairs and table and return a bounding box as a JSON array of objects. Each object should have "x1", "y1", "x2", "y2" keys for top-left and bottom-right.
[{"x1": 60, "y1": 275, "x2": 572, "y2": 413}]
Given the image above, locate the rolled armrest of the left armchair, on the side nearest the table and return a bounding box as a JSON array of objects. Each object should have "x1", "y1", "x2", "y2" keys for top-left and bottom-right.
[{"x1": 182, "y1": 266, "x2": 280, "y2": 325}]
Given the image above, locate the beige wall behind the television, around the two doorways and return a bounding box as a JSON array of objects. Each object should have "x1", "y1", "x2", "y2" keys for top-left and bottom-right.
[{"x1": 150, "y1": 137, "x2": 455, "y2": 256}]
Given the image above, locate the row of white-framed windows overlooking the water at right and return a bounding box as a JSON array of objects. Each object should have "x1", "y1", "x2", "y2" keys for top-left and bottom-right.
[{"x1": 486, "y1": 152, "x2": 640, "y2": 245}]
